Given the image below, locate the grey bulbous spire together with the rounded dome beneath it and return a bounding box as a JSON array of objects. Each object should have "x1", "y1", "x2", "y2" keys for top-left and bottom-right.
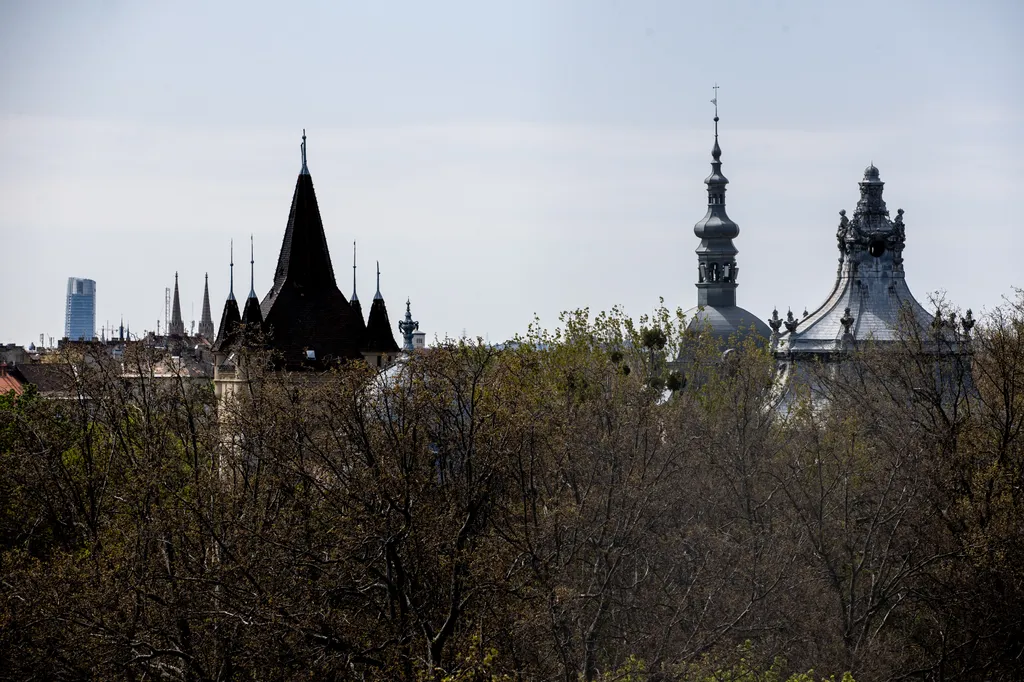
[{"x1": 686, "y1": 85, "x2": 771, "y2": 341}]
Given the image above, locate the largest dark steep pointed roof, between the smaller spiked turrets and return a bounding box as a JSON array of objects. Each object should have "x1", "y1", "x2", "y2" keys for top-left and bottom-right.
[{"x1": 260, "y1": 131, "x2": 362, "y2": 367}]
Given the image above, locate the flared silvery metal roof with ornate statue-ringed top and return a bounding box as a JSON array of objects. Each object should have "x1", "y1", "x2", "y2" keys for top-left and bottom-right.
[{"x1": 773, "y1": 164, "x2": 933, "y2": 358}]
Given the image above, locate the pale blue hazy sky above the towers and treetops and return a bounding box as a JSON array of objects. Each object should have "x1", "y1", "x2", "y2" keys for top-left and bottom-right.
[{"x1": 0, "y1": 0, "x2": 1024, "y2": 344}]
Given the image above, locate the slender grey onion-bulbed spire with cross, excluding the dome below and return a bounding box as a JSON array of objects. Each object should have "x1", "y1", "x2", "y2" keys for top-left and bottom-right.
[{"x1": 693, "y1": 84, "x2": 739, "y2": 306}]
